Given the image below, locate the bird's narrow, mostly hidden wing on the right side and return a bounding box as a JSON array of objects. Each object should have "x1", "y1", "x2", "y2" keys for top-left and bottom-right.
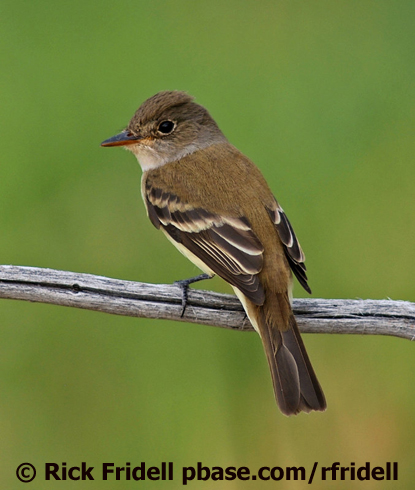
[{"x1": 267, "y1": 201, "x2": 311, "y2": 294}]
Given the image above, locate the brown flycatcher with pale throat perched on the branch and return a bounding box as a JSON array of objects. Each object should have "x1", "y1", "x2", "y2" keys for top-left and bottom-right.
[{"x1": 102, "y1": 91, "x2": 326, "y2": 415}]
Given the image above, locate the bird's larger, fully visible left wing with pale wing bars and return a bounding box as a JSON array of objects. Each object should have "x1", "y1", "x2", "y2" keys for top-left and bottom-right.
[{"x1": 144, "y1": 186, "x2": 264, "y2": 305}]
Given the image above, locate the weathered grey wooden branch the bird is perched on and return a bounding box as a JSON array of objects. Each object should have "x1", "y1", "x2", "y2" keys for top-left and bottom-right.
[{"x1": 0, "y1": 265, "x2": 415, "y2": 340}]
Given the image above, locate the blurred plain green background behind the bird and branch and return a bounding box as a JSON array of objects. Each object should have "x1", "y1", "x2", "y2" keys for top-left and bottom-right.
[{"x1": 0, "y1": 0, "x2": 415, "y2": 489}]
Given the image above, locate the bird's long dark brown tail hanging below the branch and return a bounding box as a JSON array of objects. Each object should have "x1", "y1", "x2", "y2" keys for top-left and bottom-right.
[{"x1": 260, "y1": 308, "x2": 327, "y2": 415}]
